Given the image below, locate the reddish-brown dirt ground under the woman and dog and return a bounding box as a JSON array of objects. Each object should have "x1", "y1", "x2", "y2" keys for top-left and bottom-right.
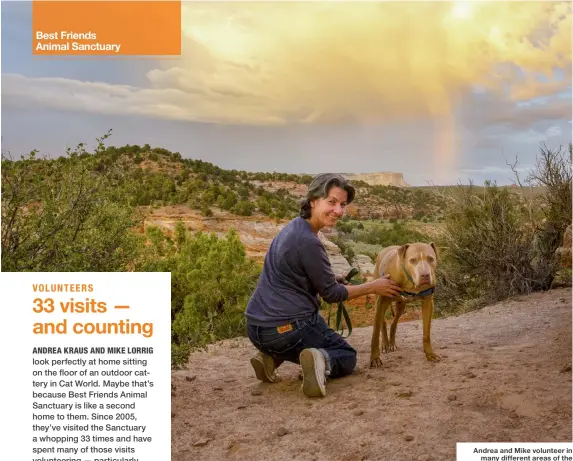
[{"x1": 171, "y1": 289, "x2": 572, "y2": 461}]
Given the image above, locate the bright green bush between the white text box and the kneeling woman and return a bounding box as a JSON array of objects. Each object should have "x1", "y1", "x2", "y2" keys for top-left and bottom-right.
[{"x1": 136, "y1": 222, "x2": 260, "y2": 368}]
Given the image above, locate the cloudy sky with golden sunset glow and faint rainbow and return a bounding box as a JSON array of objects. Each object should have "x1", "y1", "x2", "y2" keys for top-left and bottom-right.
[{"x1": 1, "y1": 1, "x2": 572, "y2": 185}]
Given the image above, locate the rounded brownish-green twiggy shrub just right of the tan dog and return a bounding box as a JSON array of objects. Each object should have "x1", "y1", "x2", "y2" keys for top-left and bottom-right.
[{"x1": 436, "y1": 177, "x2": 556, "y2": 311}]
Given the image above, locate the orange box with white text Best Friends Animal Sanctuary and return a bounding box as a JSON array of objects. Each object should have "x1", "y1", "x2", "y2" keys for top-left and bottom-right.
[{"x1": 32, "y1": 0, "x2": 181, "y2": 56}]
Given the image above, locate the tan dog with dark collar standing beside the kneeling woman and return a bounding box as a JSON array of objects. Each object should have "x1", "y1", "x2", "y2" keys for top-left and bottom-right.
[{"x1": 370, "y1": 242, "x2": 440, "y2": 368}]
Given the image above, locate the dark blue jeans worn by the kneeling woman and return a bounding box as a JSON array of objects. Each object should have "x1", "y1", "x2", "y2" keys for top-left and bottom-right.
[{"x1": 247, "y1": 314, "x2": 356, "y2": 378}]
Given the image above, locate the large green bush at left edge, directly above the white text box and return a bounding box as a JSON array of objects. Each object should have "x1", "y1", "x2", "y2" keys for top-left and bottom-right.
[{"x1": 1, "y1": 135, "x2": 142, "y2": 272}]
